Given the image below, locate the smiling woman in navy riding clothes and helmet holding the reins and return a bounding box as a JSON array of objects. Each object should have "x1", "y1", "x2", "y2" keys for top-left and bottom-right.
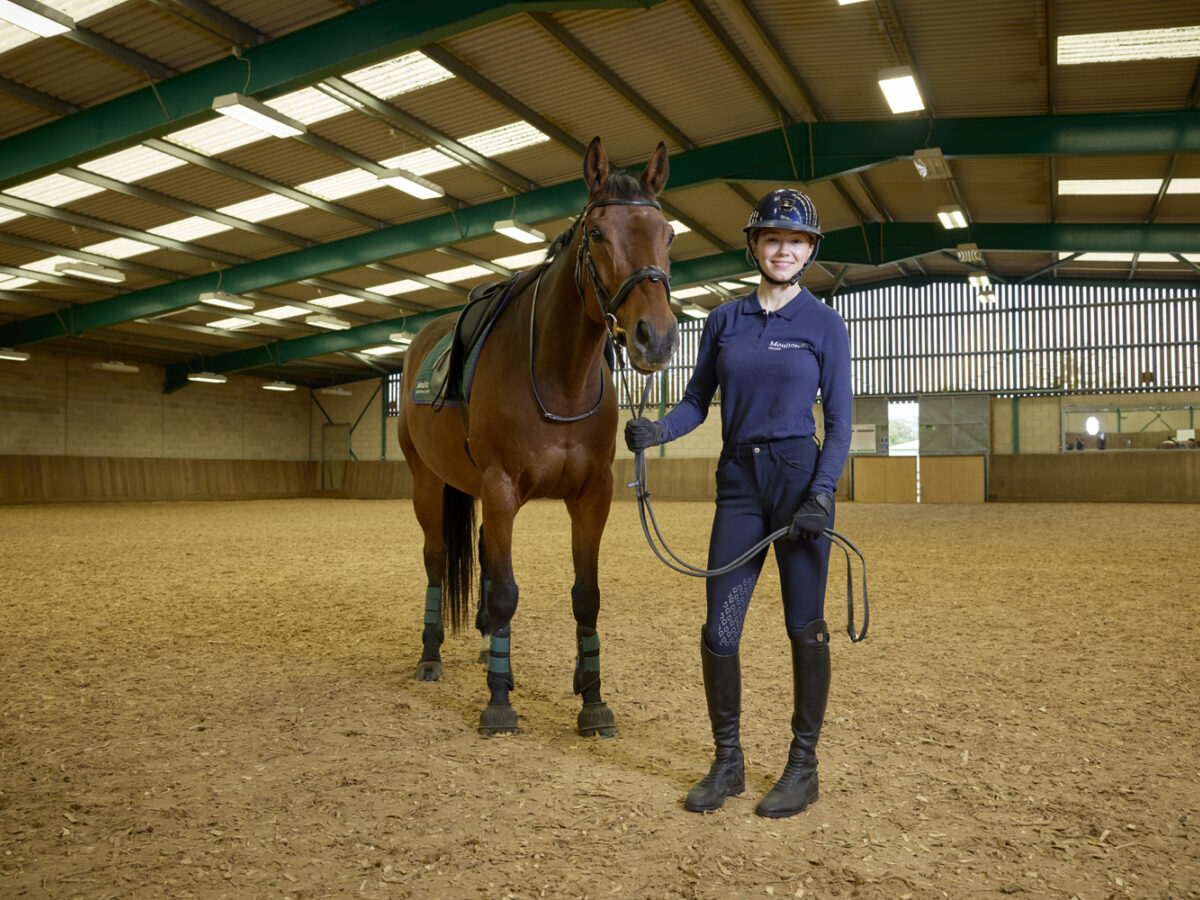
[{"x1": 625, "y1": 188, "x2": 851, "y2": 818}]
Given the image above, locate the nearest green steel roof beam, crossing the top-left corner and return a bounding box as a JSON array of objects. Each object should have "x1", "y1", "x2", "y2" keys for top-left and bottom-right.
[{"x1": 0, "y1": 0, "x2": 664, "y2": 190}]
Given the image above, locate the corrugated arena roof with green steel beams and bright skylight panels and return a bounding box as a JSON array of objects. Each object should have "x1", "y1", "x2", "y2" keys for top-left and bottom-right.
[{"x1": 0, "y1": 0, "x2": 1200, "y2": 390}]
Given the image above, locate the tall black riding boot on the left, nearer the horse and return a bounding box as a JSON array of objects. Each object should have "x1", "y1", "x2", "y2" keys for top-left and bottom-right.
[{"x1": 683, "y1": 628, "x2": 746, "y2": 812}]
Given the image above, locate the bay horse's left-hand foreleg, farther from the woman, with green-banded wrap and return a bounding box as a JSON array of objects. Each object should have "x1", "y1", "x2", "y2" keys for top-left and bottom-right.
[{"x1": 479, "y1": 489, "x2": 520, "y2": 734}]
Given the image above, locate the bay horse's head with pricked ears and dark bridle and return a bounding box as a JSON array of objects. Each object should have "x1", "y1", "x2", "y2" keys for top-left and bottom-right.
[{"x1": 575, "y1": 138, "x2": 679, "y2": 373}]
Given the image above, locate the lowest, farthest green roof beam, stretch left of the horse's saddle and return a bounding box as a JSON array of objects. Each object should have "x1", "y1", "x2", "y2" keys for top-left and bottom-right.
[{"x1": 163, "y1": 306, "x2": 462, "y2": 394}]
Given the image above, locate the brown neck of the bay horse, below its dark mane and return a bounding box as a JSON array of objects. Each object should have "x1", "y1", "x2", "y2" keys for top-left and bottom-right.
[{"x1": 529, "y1": 244, "x2": 606, "y2": 406}]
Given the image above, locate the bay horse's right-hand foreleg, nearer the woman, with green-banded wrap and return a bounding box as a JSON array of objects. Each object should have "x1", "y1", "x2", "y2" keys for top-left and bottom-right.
[{"x1": 566, "y1": 484, "x2": 617, "y2": 738}]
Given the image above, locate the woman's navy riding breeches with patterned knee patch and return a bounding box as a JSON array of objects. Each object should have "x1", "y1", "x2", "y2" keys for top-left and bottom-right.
[{"x1": 704, "y1": 437, "x2": 834, "y2": 656}]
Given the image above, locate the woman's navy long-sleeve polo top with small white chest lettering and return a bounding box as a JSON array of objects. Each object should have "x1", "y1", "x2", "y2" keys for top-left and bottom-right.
[{"x1": 660, "y1": 288, "x2": 853, "y2": 494}]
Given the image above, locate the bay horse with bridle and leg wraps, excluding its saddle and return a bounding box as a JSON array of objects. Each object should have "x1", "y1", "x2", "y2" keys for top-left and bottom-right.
[{"x1": 398, "y1": 138, "x2": 679, "y2": 737}]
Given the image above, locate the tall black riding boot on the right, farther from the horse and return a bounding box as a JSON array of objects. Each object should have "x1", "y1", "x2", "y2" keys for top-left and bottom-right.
[{"x1": 755, "y1": 619, "x2": 829, "y2": 818}]
